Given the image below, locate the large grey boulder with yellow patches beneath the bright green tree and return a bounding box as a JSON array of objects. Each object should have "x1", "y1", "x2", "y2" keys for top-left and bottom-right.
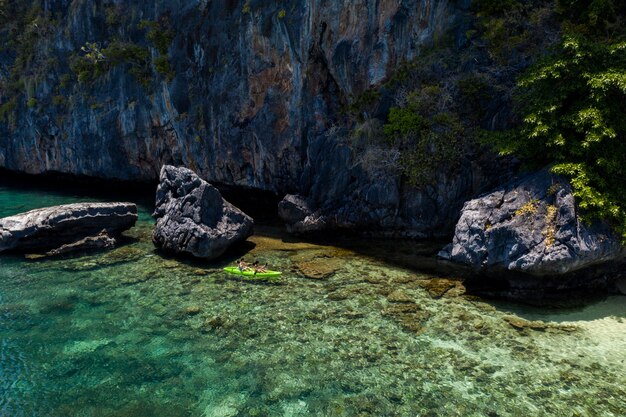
[{"x1": 443, "y1": 169, "x2": 626, "y2": 277}]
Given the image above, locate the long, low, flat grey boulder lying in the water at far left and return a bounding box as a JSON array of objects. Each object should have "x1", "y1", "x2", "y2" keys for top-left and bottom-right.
[{"x1": 0, "y1": 203, "x2": 137, "y2": 252}]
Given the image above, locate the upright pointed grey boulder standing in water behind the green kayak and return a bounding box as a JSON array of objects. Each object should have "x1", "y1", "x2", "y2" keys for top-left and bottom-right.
[{"x1": 152, "y1": 165, "x2": 254, "y2": 259}]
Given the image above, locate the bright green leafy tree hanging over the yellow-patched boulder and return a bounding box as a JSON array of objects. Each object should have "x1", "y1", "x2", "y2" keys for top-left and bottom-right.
[{"x1": 491, "y1": 0, "x2": 626, "y2": 238}]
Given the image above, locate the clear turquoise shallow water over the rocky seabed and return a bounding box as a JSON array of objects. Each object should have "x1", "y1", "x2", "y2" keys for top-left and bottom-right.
[{"x1": 0, "y1": 186, "x2": 626, "y2": 416}]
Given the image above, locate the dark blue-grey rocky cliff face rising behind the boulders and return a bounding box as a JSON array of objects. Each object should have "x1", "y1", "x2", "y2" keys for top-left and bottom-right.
[{"x1": 0, "y1": 0, "x2": 494, "y2": 236}]
